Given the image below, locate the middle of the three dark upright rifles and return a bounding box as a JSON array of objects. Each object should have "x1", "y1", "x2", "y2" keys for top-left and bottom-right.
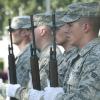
[{"x1": 30, "y1": 15, "x2": 41, "y2": 90}]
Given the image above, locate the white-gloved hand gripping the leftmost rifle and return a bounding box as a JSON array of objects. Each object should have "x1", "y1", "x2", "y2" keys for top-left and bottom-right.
[{"x1": 6, "y1": 84, "x2": 21, "y2": 97}]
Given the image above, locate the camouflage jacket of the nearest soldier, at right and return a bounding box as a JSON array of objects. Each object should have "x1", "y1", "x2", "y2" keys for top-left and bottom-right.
[{"x1": 55, "y1": 38, "x2": 100, "y2": 100}]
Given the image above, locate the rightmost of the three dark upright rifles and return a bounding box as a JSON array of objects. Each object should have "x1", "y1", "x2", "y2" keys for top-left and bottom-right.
[{"x1": 49, "y1": 12, "x2": 58, "y2": 87}]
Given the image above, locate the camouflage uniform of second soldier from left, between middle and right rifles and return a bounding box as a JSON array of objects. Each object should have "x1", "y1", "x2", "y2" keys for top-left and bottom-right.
[{"x1": 13, "y1": 45, "x2": 62, "y2": 100}]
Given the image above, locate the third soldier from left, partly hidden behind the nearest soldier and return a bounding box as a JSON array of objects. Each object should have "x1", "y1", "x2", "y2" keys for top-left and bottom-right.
[{"x1": 56, "y1": 17, "x2": 78, "y2": 87}]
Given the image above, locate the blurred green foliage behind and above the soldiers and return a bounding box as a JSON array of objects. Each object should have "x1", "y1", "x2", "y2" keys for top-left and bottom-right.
[{"x1": 0, "y1": 0, "x2": 100, "y2": 35}]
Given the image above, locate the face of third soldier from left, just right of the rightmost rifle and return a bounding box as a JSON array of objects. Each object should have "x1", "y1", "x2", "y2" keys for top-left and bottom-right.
[{"x1": 56, "y1": 24, "x2": 69, "y2": 46}]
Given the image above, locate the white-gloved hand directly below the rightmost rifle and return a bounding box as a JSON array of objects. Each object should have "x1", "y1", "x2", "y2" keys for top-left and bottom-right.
[{"x1": 44, "y1": 87, "x2": 64, "y2": 100}]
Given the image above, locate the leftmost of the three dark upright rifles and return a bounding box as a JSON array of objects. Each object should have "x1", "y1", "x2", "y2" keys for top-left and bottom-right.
[{"x1": 8, "y1": 19, "x2": 17, "y2": 100}]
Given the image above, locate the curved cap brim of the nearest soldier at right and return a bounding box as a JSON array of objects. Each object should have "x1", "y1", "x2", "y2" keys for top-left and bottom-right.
[{"x1": 61, "y1": 14, "x2": 80, "y2": 23}]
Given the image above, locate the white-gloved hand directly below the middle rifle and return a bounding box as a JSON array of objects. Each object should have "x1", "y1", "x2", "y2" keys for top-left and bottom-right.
[{"x1": 28, "y1": 89, "x2": 44, "y2": 100}]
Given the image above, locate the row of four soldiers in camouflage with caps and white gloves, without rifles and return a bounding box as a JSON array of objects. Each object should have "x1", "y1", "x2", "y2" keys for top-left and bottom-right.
[{"x1": 0, "y1": 2, "x2": 100, "y2": 100}]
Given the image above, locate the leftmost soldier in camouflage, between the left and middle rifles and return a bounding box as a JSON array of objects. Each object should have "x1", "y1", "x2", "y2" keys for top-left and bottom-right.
[{"x1": 11, "y1": 16, "x2": 31, "y2": 87}]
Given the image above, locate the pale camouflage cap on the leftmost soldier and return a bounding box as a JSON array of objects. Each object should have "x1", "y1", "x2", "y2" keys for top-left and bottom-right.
[{"x1": 11, "y1": 16, "x2": 31, "y2": 29}]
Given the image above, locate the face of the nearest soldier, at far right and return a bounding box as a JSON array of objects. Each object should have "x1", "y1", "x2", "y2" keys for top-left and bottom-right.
[{"x1": 69, "y1": 21, "x2": 85, "y2": 47}]
